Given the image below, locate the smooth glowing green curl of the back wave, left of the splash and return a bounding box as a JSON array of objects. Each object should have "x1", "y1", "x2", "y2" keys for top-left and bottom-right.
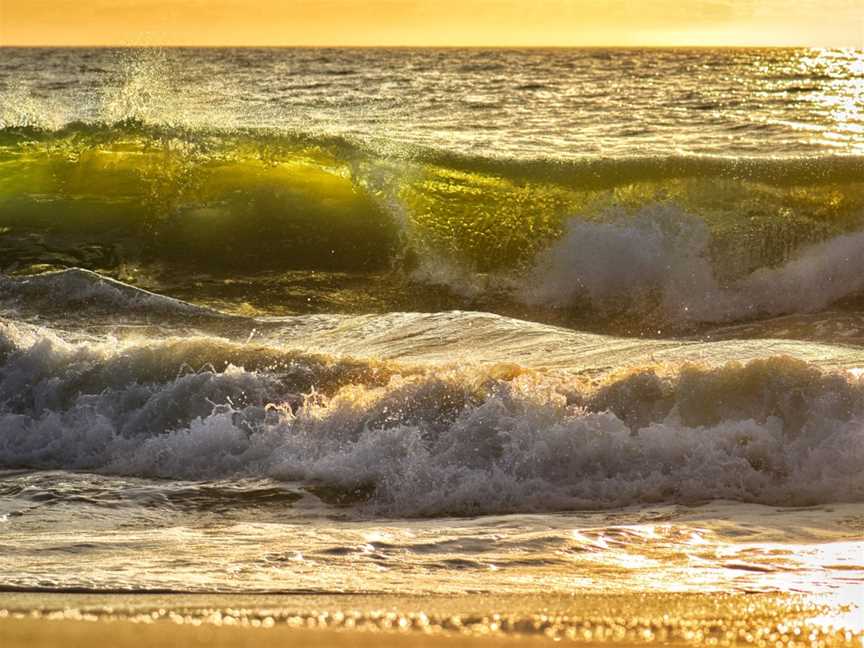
[{"x1": 0, "y1": 126, "x2": 398, "y2": 274}]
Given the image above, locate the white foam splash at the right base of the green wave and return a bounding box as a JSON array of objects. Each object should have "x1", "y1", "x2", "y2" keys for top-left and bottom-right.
[{"x1": 519, "y1": 205, "x2": 864, "y2": 322}]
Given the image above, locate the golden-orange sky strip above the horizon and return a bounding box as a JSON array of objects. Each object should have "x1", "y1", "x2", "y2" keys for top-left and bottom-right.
[{"x1": 0, "y1": 0, "x2": 864, "y2": 47}]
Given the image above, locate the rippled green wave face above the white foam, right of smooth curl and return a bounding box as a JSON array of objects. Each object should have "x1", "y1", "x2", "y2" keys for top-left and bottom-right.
[{"x1": 401, "y1": 156, "x2": 864, "y2": 278}]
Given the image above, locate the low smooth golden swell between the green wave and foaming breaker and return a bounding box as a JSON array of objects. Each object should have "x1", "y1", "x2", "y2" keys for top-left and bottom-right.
[{"x1": 0, "y1": 269, "x2": 862, "y2": 368}]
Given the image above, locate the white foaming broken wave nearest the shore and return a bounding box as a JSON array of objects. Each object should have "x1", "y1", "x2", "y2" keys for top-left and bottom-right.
[{"x1": 0, "y1": 322, "x2": 864, "y2": 517}]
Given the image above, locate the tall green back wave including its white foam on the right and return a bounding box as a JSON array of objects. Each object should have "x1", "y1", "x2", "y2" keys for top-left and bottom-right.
[{"x1": 0, "y1": 120, "x2": 864, "y2": 321}]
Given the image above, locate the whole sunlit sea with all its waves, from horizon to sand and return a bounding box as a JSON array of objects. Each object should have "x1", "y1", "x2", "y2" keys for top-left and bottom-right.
[{"x1": 0, "y1": 49, "x2": 864, "y2": 633}]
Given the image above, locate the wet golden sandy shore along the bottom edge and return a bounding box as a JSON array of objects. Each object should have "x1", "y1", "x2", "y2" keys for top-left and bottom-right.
[{"x1": 0, "y1": 593, "x2": 864, "y2": 648}]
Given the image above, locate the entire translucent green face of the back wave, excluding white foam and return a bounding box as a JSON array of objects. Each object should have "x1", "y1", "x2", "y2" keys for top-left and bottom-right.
[{"x1": 0, "y1": 122, "x2": 864, "y2": 284}]
